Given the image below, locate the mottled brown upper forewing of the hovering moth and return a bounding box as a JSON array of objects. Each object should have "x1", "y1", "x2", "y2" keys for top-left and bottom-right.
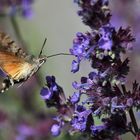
[{"x1": 0, "y1": 32, "x2": 27, "y2": 58}]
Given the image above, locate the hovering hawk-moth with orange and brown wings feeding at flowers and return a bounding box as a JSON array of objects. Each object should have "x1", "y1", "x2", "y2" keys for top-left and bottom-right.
[{"x1": 0, "y1": 32, "x2": 47, "y2": 93}]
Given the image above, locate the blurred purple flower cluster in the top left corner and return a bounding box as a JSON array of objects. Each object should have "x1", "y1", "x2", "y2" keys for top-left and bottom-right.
[{"x1": 0, "y1": 0, "x2": 34, "y2": 18}]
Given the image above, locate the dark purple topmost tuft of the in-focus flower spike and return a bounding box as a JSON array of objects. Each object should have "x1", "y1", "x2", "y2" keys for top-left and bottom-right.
[{"x1": 74, "y1": 0, "x2": 111, "y2": 29}]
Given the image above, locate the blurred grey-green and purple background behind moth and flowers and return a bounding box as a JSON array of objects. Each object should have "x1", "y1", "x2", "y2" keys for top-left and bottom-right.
[{"x1": 0, "y1": 0, "x2": 140, "y2": 140}]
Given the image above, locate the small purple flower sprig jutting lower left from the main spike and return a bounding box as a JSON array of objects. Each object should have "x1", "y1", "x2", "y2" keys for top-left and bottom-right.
[{"x1": 40, "y1": 76, "x2": 74, "y2": 136}]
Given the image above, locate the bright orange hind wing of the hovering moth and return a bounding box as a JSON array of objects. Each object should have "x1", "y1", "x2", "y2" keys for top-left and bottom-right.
[{"x1": 0, "y1": 51, "x2": 27, "y2": 80}]
